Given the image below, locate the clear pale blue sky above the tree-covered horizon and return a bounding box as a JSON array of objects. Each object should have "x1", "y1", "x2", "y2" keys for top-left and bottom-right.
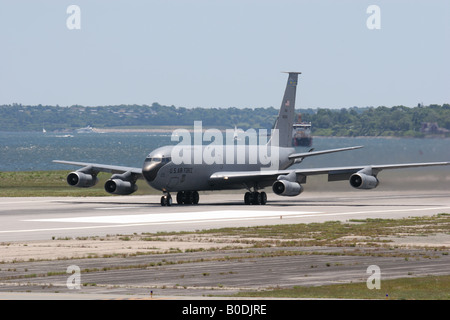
[{"x1": 0, "y1": 0, "x2": 450, "y2": 108}]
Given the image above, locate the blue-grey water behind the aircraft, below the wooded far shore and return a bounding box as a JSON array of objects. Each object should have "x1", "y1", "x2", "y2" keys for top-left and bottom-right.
[{"x1": 0, "y1": 132, "x2": 450, "y2": 171}]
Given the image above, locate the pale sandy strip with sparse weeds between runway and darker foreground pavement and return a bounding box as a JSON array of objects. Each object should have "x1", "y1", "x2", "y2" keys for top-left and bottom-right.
[{"x1": 0, "y1": 234, "x2": 450, "y2": 263}]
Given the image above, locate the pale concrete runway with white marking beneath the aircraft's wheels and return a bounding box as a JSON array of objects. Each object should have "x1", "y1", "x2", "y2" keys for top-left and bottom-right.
[{"x1": 0, "y1": 190, "x2": 450, "y2": 242}]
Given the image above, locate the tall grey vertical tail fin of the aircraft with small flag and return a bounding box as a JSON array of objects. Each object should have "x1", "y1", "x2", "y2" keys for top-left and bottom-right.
[{"x1": 268, "y1": 72, "x2": 301, "y2": 147}]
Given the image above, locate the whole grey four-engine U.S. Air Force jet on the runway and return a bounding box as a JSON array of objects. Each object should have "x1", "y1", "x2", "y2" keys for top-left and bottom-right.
[{"x1": 53, "y1": 72, "x2": 450, "y2": 206}]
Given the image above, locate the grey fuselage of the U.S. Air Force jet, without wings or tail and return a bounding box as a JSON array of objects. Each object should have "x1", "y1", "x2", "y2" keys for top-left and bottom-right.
[{"x1": 142, "y1": 145, "x2": 295, "y2": 192}]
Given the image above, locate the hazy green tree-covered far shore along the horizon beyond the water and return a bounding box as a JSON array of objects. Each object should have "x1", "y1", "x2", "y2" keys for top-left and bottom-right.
[{"x1": 0, "y1": 103, "x2": 450, "y2": 137}]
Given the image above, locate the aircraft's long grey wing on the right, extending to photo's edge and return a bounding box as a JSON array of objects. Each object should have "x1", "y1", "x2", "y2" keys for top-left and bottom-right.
[{"x1": 210, "y1": 162, "x2": 450, "y2": 183}]
